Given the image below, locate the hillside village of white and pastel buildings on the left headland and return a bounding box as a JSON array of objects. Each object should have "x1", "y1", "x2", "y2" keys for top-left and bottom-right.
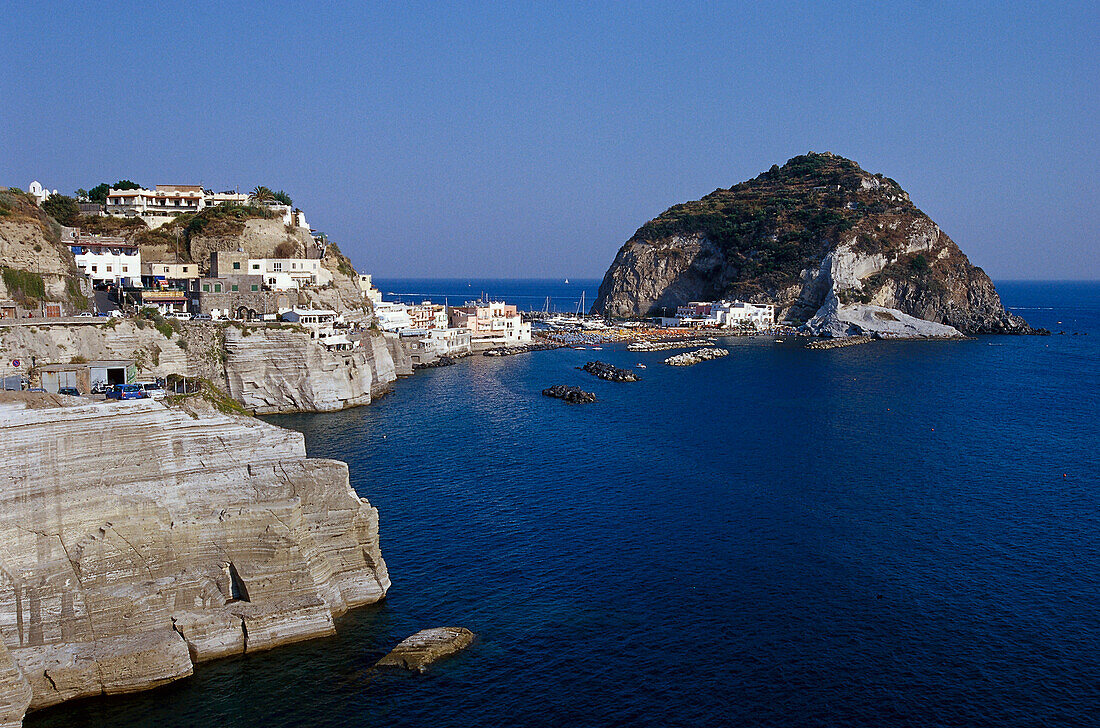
[{"x1": 0, "y1": 180, "x2": 531, "y2": 394}]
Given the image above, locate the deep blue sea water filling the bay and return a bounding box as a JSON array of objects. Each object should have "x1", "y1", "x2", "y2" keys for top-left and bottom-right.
[{"x1": 26, "y1": 283, "x2": 1100, "y2": 728}]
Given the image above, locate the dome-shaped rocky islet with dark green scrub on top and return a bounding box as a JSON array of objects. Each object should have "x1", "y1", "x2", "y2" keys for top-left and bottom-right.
[{"x1": 593, "y1": 153, "x2": 1030, "y2": 333}]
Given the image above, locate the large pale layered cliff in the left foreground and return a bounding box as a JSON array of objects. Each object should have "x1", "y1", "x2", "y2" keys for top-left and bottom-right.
[{"x1": 0, "y1": 394, "x2": 389, "y2": 725}]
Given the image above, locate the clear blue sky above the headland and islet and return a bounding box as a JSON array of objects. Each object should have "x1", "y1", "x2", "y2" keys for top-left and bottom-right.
[{"x1": 0, "y1": 0, "x2": 1100, "y2": 279}]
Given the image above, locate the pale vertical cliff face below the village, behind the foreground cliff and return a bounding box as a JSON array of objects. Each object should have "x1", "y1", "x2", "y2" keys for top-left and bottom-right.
[{"x1": 226, "y1": 327, "x2": 396, "y2": 413}]
